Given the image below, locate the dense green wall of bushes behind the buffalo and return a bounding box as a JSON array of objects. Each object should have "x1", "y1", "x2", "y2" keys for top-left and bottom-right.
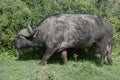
[{"x1": 0, "y1": 0, "x2": 120, "y2": 58}]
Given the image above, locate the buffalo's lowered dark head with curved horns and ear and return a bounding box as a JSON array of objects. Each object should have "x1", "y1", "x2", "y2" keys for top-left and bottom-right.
[{"x1": 14, "y1": 26, "x2": 38, "y2": 49}]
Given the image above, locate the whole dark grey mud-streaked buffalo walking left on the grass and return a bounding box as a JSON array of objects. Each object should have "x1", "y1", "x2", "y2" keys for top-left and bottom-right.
[{"x1": 14, "y1": 14, "x2": 113, "y2": 66}]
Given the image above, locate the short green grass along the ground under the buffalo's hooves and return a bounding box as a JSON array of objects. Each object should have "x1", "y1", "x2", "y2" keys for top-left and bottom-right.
[{"x1": 0, "y1": 56, "x2": 120, "y2": 80}]
